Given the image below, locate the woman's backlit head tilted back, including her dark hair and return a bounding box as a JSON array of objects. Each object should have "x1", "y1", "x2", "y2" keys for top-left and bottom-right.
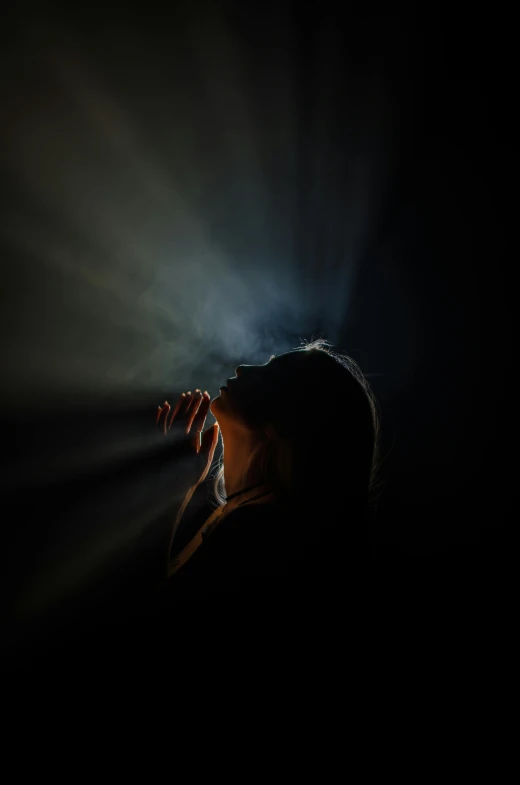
[{"x1": 211, "y1": 339, "x2": 379, "y2": 516}]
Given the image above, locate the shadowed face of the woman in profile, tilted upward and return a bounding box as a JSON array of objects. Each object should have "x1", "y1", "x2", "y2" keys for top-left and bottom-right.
[{"x1": 210, "y1": 350, "x2": 304, "y2": 429}]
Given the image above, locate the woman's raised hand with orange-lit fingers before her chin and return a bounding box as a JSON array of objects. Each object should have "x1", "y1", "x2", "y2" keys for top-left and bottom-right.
[{"x1": 156, "y1": 389, "x2": 219, "y2": 494}]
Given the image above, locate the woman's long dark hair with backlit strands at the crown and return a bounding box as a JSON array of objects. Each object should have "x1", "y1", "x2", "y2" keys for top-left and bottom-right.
[{"x1": 209, "y1": 338, "x2": 380, "y2": 513}]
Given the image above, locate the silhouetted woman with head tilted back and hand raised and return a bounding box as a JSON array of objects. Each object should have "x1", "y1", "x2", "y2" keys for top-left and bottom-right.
[{"x1": 157, "y1": 339, "x2": 379, "y2": 612}]
